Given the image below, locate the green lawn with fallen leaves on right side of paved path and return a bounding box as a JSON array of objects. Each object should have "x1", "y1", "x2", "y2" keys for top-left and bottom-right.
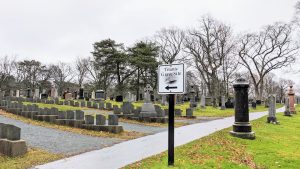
[{"x1": 125, "y1": 106, "x2": 300, "y2": 169}]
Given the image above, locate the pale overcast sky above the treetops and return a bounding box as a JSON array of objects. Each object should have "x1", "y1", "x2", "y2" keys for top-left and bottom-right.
[{"x1": 0, "y1": 0, "x2": 296, "y2": 84}]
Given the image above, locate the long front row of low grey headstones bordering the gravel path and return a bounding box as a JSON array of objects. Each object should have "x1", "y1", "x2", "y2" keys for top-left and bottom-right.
[{"x1": 0, "y1": 100, "x2": 123, "y2": 132}]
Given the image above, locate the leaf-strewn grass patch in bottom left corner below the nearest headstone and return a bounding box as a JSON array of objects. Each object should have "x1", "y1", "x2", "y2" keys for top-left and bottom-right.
[{"x1": 0, "y1": 148, "x2": 64, "y2": 169}]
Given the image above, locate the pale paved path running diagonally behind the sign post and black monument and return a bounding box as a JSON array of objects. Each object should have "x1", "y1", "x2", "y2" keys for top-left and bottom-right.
[{"x1": 34, "y1": 107, "x2": 284, "y2": 169}]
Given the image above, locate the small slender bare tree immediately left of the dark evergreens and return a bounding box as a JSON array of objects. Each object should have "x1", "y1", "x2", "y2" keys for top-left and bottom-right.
[{"x1": 76, "y1": 58, "x2": 90, "y2": 87}]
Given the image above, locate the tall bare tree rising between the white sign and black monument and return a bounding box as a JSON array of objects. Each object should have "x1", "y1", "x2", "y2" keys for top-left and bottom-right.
[{"x1": 184, "y1": 16, "x2": 233, "y2": 105}]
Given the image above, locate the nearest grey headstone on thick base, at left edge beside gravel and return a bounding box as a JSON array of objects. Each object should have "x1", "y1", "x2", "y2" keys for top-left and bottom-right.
[{"x1": 0, "y1": 123, "x2": 27, "y2": 157}]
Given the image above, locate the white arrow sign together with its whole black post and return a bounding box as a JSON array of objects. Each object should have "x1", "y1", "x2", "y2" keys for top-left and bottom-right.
[{"x1": 157, "y1": 64, "x2": 186, "y2": 166}]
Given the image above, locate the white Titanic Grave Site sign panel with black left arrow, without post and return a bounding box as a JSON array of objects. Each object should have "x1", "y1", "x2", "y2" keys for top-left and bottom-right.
[{"x1": 158, "y1": 64, "x2": 186, "y2": 94}]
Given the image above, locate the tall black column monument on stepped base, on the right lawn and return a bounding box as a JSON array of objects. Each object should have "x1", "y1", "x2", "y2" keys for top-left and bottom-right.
[{"x1": 230, "y1": 79, "x2": 255, "y2": 139}]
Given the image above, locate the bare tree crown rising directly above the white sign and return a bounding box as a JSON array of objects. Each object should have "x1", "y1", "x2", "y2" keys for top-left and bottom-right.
[{"x1": 155, "y1": 27, "x2": 184, "y2": 64}]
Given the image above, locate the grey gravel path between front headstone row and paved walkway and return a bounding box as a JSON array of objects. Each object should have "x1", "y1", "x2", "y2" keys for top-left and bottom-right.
[{"x1": 0, "y1": 115, "x2": 122, "y2": 155}]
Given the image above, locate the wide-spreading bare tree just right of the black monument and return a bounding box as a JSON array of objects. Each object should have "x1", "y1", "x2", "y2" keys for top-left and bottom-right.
[{"x1": 238, "y1": 23, "x2": 298, "y2": 100}]
